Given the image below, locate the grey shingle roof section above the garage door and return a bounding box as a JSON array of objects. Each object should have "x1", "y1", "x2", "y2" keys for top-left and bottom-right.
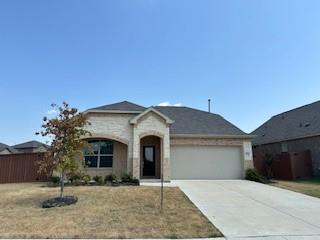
[{"x1": 154, "y1": 106, "x2": 249, "y2": 137}]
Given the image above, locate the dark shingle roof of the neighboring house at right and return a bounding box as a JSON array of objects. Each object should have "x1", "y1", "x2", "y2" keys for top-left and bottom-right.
[{"x1": 252, "y1": 101, "x2": 320, "y2": 145}]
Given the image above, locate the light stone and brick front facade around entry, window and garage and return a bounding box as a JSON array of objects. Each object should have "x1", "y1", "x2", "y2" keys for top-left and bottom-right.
[{"x1": 86, "y1": 111, "x2": 253, "y2": 181}]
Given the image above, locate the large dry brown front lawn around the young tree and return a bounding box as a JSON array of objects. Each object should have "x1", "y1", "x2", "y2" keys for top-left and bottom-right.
[{"x1": 0, "y1": 184, "x2": 221, "y2": 238}]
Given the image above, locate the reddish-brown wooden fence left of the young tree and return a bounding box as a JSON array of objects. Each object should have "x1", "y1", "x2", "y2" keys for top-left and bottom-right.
[{"x1": 0, "y1": 153, "x2": 47, "y2": 183}]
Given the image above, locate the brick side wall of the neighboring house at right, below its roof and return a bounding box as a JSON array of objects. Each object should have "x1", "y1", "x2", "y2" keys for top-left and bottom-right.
[{"x1": 253, "y1": 136, "x2": 320, "y2": 176}]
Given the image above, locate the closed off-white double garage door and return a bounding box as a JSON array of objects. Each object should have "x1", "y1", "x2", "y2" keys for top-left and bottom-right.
[{"x1": 171, "y1": 146, "x2": 243, "y2": 179}]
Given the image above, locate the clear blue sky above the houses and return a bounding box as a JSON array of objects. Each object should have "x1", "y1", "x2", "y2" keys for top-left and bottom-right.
[{"x1": 0, "y1": 0, "x2": 320, "y2": 145}]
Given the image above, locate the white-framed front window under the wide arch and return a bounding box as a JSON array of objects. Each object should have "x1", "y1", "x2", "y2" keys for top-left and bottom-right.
[{"x1": 84, "y1": 140, "x2": 113, "y2": 168}]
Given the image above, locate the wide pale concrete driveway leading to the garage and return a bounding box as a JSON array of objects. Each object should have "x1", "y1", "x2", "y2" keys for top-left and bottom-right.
[{"x1": 173, "y1": 180, "x2": 320, "y2": 240}]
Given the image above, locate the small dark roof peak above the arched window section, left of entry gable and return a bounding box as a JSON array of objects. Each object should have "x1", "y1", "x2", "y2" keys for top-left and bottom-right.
[{"x1": 86, "y1": 101, "x2": 146, "y2": 112}]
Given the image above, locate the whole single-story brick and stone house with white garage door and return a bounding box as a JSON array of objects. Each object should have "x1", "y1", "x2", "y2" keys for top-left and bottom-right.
[{"x1": 81, "y1": 101, "x2": 253, "y2": 181}]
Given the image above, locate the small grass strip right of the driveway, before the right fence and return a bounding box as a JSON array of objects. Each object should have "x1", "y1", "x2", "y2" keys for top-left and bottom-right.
[{"x1": 272, "y1": 177, "x2": 320, "y2": 198}]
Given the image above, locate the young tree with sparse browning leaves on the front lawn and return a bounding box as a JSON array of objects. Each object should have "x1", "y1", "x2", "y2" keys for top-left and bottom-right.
[{"x1": 36, "y1": 102, "x2": 90, "y2": 198}]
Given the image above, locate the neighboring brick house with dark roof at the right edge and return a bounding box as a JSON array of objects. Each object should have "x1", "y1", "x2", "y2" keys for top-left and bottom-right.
[{"x1": 252, "y1": 101, "x2": 320, "y2": 175}]
